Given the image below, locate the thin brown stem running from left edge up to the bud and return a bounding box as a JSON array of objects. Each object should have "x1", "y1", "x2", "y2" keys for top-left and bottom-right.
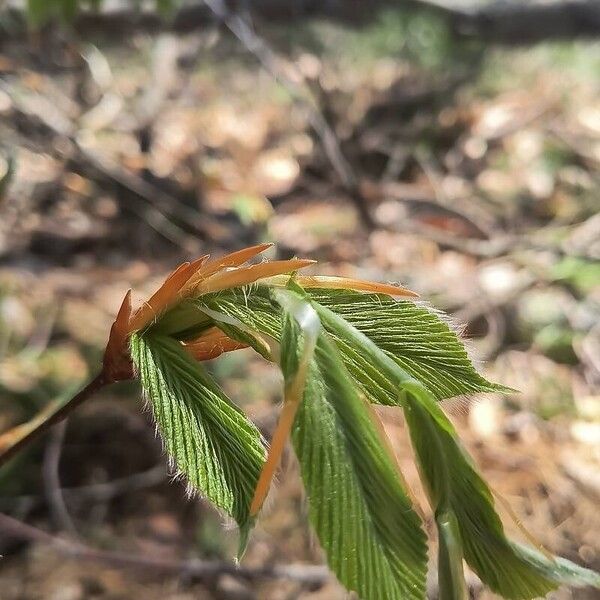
[{"x1": 0, "y1": 371, "x2": 111, "y2": 467}]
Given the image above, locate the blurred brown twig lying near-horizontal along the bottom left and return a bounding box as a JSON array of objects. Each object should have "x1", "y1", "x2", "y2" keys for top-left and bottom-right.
[{"x1": 0, "y1": 513, "x2": 329, "y2": 587}]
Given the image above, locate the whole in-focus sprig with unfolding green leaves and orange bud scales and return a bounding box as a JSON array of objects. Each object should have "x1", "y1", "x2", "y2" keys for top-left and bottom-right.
[{"x1": 0, "y1": 244, "x2": 600, "y2": 600}]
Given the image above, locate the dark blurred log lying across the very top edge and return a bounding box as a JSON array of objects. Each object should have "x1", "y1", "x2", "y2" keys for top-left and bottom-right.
[{"x1": 0, "y1": 0, "x2": 600, "y2": 44}]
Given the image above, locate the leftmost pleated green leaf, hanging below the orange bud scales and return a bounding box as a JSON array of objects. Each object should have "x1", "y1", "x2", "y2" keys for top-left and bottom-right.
[{"x1": 131, "y1": 333, "x2": 265, "y2": 528}]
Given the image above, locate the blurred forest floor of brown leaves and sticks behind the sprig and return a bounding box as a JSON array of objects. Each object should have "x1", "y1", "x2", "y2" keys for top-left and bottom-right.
[{"x1": 0, "y1": 0, "x2": 600, "y2": 600}]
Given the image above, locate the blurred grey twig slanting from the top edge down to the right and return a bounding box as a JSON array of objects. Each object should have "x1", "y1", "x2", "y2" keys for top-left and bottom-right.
[{"x1": 204, "y1": 0, "x2": 376, "y2": 229}]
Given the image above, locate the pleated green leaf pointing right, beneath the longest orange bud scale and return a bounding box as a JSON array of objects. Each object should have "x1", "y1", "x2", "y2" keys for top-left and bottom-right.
[{"x1": 177, "y1": 285, "x2": 510, "y2": 406}]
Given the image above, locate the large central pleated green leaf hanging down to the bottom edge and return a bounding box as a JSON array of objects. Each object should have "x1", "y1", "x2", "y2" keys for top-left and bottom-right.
[{"x1": 290, "y1": 335, "x2": 427, "y2": 600}]
